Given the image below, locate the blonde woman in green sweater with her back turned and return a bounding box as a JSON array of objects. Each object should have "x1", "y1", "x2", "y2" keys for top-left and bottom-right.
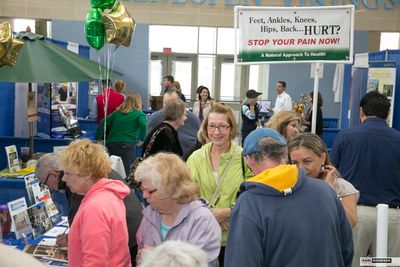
[{"x1": 96, "y1": 93, "x2": 147, "y2": 175}]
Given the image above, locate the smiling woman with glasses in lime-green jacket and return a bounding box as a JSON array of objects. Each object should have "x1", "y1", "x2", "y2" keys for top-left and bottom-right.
[{"x1": 187, "y1": 103, "x2": 250, "y2": 266}]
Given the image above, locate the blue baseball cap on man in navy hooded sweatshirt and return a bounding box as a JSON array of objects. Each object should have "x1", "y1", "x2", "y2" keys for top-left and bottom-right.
[{"x1": 243, "y1": 128, "x2": 286, "y2": 156}]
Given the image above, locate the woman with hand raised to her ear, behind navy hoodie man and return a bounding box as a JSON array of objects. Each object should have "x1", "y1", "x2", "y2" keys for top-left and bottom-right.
[{"x1": 288, "y1": 133, "x2": 359, "y2": 227}]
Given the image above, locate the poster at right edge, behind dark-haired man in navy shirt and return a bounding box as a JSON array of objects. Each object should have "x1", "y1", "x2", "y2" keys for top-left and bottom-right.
[{"x1": 367, "y1": 61, "x2": 396, "y2": 127}]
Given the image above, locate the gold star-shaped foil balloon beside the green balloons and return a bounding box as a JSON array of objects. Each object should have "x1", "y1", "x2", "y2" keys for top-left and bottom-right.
[{"x1": 103, "y1": 2, "x2": 136, "y2": 47}]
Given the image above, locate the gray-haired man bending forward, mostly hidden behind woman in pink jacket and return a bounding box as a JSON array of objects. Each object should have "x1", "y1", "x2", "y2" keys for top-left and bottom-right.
[{"x1": 35, "y1": 153, "x2": 142, "y2": 266}]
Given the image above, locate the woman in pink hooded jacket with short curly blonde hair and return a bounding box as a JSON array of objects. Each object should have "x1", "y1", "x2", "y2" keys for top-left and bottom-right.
[{"x1": 60, "y1": 139, "x2": 131, "y2": 267}]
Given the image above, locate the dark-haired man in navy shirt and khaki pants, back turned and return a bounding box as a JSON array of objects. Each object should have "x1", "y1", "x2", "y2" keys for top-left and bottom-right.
[{"x1": 331, "y1": 91, "x2": 400, "y2": 266}]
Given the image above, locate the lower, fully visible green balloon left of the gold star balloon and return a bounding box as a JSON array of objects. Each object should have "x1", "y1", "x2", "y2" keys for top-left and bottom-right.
[{"x1": 85, "y1": 8, "x2": 106, "y2": 50}]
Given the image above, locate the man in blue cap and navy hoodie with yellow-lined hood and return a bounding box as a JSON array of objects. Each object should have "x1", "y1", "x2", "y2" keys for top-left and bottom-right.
[{"x1": 225, "y1": 128, "x2": 353, "y2": 267}]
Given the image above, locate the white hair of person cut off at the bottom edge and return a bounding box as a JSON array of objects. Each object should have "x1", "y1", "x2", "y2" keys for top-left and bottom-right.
[{"x1": 141, "y1": 240, "x2": 208, "y2": 267}]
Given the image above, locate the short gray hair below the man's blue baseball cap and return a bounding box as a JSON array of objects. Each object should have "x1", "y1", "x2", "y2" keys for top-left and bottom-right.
[{"x1": 249, "y1": 137, "x2": 288, "y2": 163}]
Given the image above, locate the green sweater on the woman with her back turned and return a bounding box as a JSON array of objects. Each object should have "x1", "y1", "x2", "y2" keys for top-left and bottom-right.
[{"x1": 96, "y1": 110, "x2": 147, "y2": 144}]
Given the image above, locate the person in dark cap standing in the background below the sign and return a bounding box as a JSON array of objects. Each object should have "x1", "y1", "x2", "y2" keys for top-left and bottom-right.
[{"x1": 242, "y1": 89, "x2": 262, "y2": 144}]
